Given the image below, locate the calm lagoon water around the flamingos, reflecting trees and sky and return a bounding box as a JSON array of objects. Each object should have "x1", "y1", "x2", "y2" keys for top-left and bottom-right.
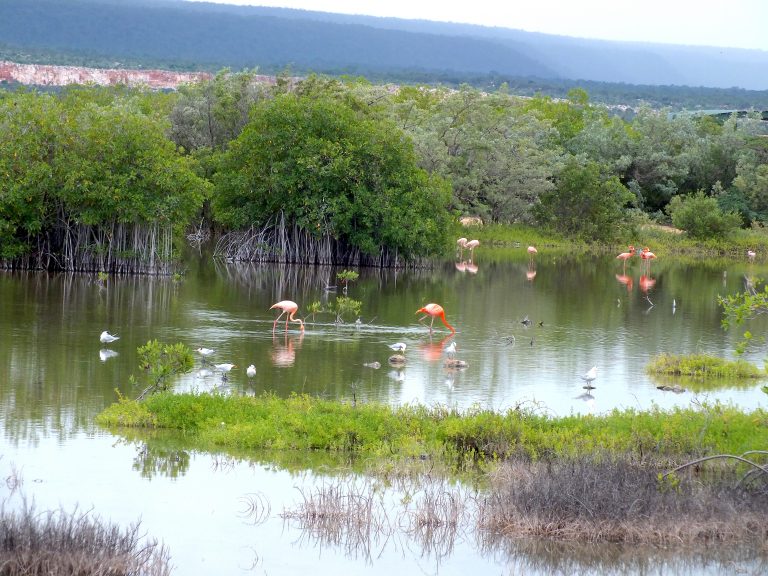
[{"x1": 0, "y1": 249, "x2": 768, "y2": 576}]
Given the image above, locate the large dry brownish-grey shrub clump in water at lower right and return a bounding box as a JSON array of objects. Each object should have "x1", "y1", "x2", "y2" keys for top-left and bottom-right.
[{"x1": 478, "y1": 453, "x2": 768, "y2": 545}]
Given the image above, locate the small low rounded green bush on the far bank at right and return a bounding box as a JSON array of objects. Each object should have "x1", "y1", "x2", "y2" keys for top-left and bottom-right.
[{"x1": 667, "y1": 191, "x2": 741, "y2": 239}]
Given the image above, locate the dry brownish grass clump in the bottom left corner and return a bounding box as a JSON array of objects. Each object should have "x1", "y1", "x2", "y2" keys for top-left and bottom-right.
[{"x1": 0, "y1": 503, "x2": 171, "y2": 576}]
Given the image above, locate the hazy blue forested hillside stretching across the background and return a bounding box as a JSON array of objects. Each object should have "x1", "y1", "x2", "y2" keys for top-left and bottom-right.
[{"x1": 0, "y1": 0, "x2": 768, "y2": 109}]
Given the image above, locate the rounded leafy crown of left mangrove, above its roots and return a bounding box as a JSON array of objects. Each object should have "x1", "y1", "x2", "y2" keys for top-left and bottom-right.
[{"x1": 56, "y1": 102, "x2": 205, "y2": 228}]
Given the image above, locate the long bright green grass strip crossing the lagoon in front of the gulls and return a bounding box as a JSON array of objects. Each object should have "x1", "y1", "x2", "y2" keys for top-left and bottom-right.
[{"x1": 97, "y1": 393, "x2": 768, "y2": 464}]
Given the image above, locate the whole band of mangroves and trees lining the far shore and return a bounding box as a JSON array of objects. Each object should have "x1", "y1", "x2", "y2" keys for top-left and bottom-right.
[{"x1": 0, "y1": 70, "x2": 768, "y2": 272}]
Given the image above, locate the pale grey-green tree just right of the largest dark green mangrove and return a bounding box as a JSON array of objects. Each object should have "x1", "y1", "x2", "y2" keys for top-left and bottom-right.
[{"x1": 395, "y1": 86, "x2": 560, "y2": 222}]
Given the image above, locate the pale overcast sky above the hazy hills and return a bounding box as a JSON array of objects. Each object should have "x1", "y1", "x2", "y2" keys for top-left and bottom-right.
[{"x1": 186, "y1": 0, "x2": 768, "y2": 51}]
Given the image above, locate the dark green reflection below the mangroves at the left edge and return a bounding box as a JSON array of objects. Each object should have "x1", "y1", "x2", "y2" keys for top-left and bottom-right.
[{"x1": 0, "y1": 272, "x2": 176, "y2": 439}]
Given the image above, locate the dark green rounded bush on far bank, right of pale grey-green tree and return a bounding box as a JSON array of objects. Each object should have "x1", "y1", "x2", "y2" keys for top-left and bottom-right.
[{"x1": 536, "y1": 157, "x2": 633, "y2": 241}]
